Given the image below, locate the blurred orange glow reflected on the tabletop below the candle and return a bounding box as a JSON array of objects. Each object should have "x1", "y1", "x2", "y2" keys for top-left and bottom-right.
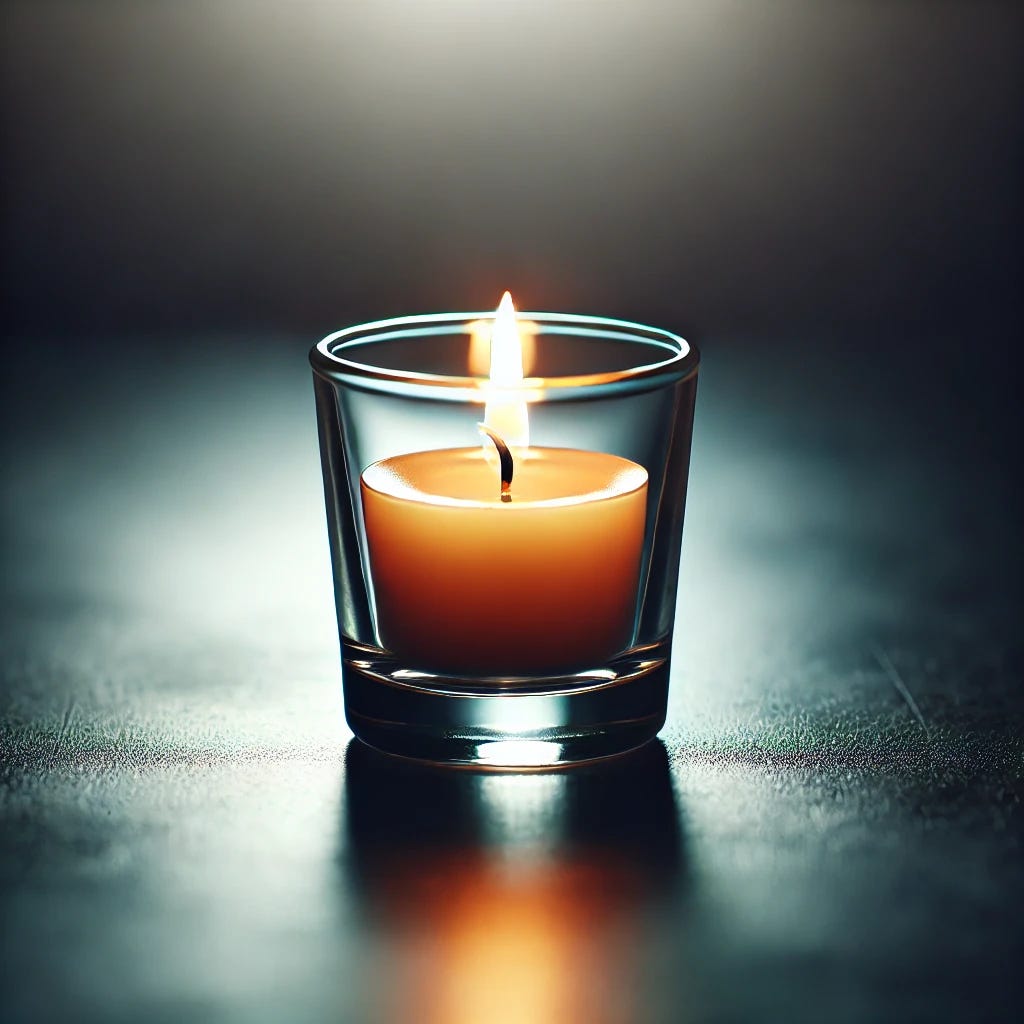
[{"x1": 388, "y1": 858, "x2": 637, "y2": 1024}]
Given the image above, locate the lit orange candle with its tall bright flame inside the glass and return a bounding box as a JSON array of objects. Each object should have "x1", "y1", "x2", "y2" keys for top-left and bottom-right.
[{"x1": 361, "y1": 293, "x2": 647, "y2": 676}]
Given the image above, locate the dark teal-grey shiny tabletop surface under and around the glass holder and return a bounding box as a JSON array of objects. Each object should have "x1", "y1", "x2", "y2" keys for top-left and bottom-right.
[{"x1": 0, "y1": 337, "x2": 1024, "y2": 1024}]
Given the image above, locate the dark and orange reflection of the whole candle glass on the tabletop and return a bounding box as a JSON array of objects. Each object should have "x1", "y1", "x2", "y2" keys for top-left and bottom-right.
[{"x1": 344, "y1": 740, "x2": 685, "y2": 1024}]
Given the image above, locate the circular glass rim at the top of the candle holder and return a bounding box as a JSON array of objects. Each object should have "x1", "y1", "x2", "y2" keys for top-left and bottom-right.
[{"x1": 309, "y1": 309, "x2": 700, "y2": 401}]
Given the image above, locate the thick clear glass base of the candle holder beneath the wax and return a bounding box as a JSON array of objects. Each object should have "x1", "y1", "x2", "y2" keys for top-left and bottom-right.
[{"x1": 342, "y1": 637, "x2": 671, "y2": 771}]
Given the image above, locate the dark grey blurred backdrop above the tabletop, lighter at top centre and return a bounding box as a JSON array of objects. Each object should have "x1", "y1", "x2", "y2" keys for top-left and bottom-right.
[{"x1": 3, "y1": 0, "x2": 1022, "y2": 339}]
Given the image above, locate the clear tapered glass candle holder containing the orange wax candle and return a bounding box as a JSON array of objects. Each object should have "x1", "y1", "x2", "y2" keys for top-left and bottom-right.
[{"x1": 310, "y1": 312, "x2": 698, "y2": 769}]
